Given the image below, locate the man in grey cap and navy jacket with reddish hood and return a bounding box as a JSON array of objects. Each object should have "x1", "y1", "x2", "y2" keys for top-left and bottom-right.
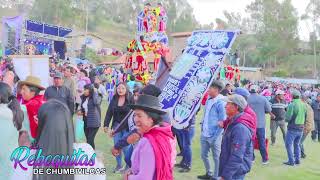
[{"x1": 219, "y1": 94, "x2": 253, "y2": 180}]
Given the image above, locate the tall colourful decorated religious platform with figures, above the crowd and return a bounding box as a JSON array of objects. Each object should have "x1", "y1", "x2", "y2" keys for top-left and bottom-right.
[{"x1": 125, "y1": 3, "x2": 169, "y2": 74}]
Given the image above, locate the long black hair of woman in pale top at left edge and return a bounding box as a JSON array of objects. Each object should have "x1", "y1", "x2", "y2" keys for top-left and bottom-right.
[{"x1": 0, "y1": 82, "x2": 24, "y2": 131}]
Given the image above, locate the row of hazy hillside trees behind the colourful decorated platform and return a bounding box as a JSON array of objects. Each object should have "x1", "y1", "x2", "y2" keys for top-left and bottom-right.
[{"x1": 28, "y1": 0, "x2": 199, "y2": 32}]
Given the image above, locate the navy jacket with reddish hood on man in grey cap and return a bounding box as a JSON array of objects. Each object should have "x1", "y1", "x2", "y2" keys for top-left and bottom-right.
[{"x1": 219, "y1": 113, "x2": 253, "y2": 180}]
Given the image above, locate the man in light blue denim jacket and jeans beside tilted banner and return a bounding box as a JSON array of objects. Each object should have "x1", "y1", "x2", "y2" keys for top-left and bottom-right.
[{"x1": 198, "y1": 80, "x2": 227, "y2": 179}]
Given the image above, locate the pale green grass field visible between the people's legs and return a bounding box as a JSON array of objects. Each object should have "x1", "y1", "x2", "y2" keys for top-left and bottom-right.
[{"x1": 80, "y1": 102, "x2": 320, "y2": 180}]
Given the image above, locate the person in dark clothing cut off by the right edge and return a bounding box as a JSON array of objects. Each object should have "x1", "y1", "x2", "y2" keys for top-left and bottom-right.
[{"x1": 311, "y1": 93, "x2": 320, "y2": 142}]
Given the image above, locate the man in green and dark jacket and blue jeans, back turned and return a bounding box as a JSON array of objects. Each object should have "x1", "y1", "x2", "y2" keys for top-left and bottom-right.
[{"x1": 283, "y1": 90, "x2": 307, "y2": 166}]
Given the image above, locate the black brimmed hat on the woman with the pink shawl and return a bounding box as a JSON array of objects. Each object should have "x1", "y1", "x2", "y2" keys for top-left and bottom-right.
[{"x1": 129, "y1": 94, "x2": 166, "y2": 114}]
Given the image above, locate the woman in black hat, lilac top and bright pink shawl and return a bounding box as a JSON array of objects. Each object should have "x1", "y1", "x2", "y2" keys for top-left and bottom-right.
[{"x1": 124, "y1": 95, "x2": 176, "y2": 180}]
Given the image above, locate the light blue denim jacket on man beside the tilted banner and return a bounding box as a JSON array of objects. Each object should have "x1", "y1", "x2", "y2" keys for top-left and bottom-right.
[{"x1": 201, "y1": 94, "x2": 227, "y2": 137}]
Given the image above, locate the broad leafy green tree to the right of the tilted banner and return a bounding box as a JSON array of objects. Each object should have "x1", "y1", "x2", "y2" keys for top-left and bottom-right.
[{"x1": 246, "y1": 0, "x2": 298, "y2": 63}]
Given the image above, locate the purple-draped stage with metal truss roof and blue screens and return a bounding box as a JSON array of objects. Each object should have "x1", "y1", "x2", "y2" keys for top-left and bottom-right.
[{"x1": 2, "y1": 16, "x2": 72, "y2": 55}]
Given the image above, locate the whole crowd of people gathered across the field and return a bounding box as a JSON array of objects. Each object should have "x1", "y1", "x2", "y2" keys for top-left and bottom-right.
[{"x1": 0, "y1": 54, "x2": 320, "y2": 180}]
